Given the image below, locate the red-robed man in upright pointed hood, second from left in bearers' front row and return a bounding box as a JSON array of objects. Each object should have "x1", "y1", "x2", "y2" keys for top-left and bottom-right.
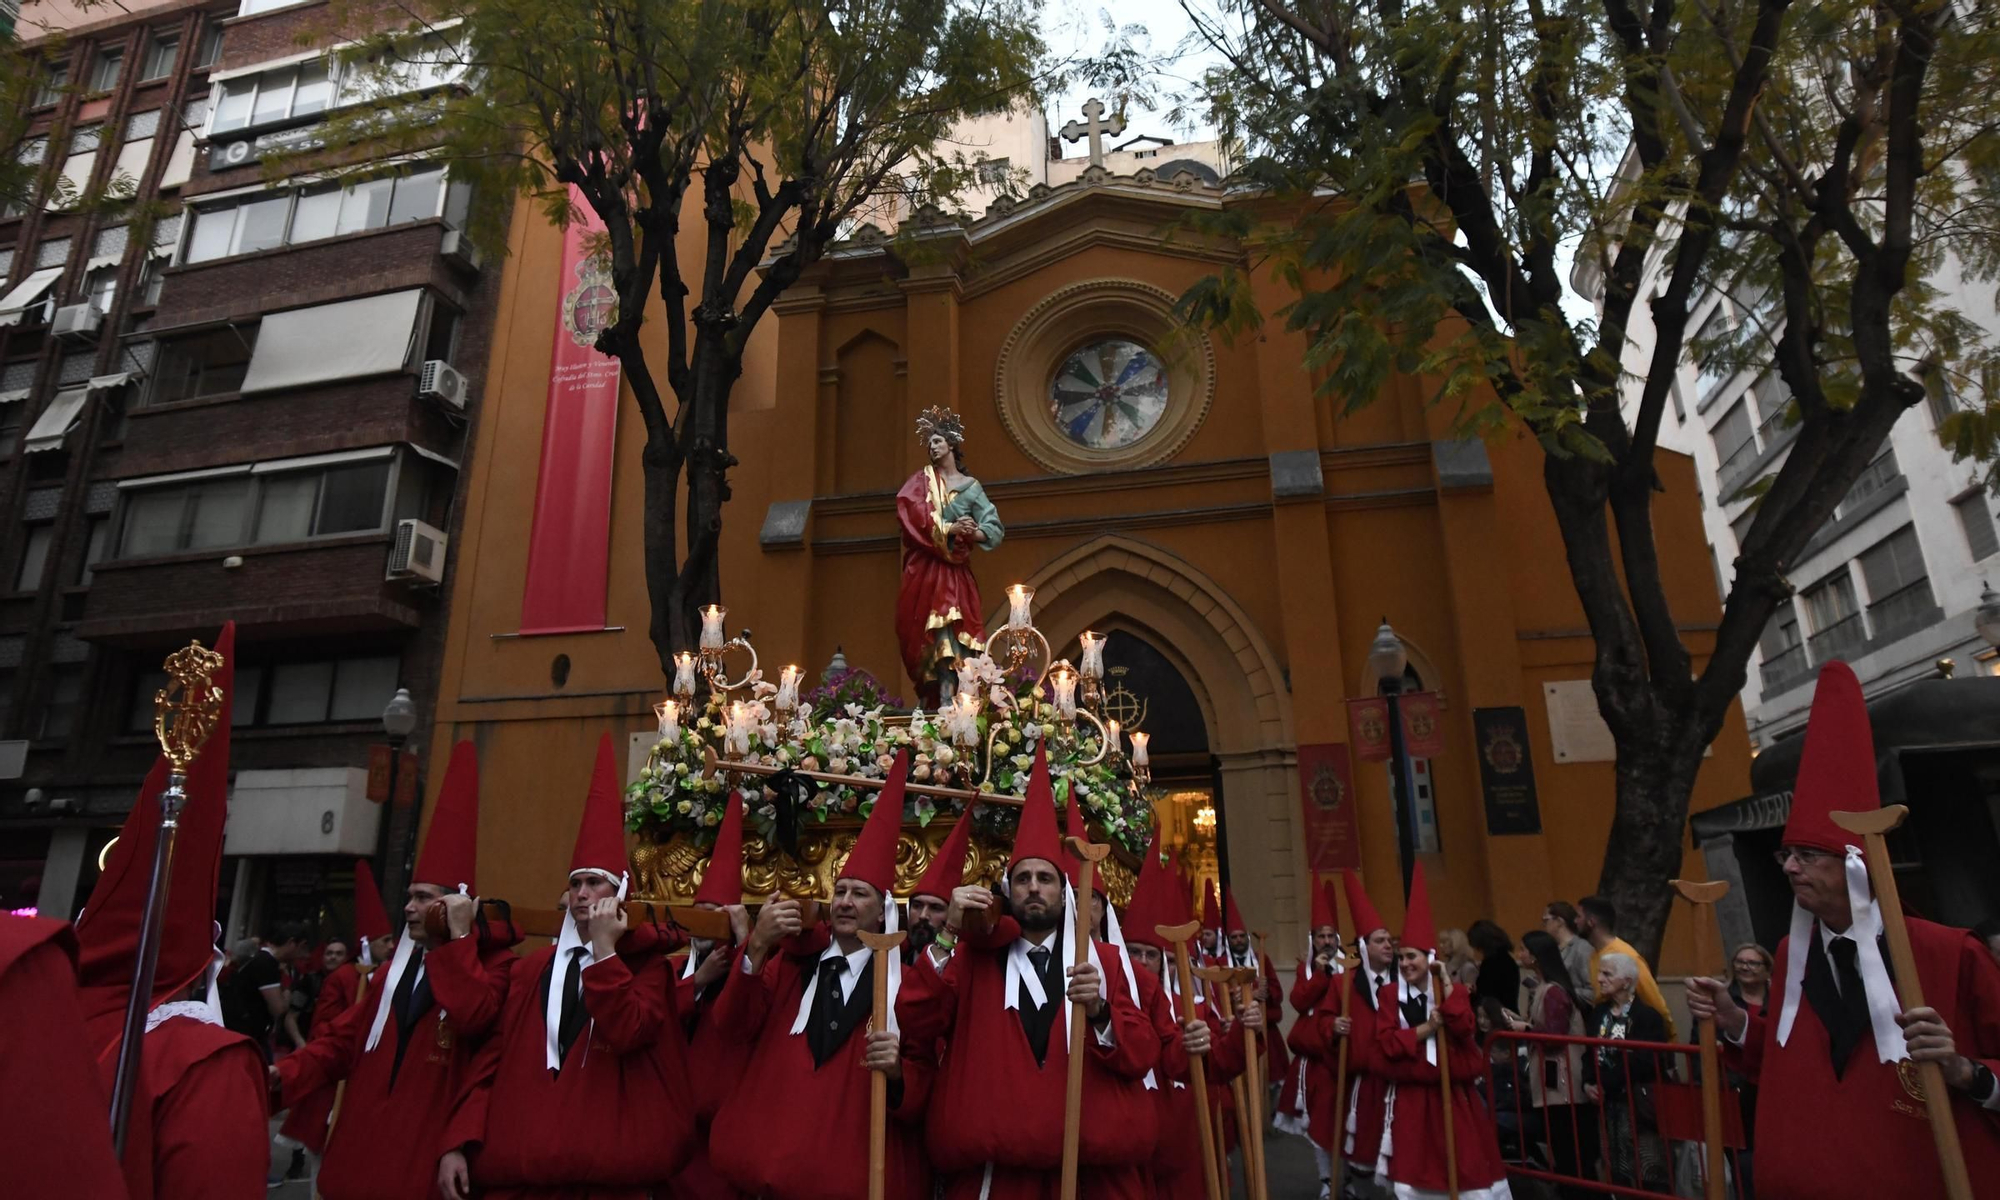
[{"x1": 438, "y1": 734, "x2": 694, "y2": 1200}]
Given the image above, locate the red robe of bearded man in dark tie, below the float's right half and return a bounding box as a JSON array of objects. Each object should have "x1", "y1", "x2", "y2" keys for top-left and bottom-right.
[{"x1": 896, "y1": 942, "x2": 1160, "y2": 1200}]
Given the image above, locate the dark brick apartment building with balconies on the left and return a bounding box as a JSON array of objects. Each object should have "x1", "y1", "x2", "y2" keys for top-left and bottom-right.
[{"x1": 0, "y1": 0, "x2": 498, "y2": 932}]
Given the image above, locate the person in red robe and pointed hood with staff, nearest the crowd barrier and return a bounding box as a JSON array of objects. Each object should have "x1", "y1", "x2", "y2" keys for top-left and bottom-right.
[{"x1": 1372, "y1": 862, "x2": 1512, "y2": 1200}]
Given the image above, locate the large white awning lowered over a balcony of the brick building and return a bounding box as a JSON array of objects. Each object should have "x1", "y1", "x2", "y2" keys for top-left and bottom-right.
[{"x1": 242, "y1": 288, "x2": 424, "y2": 394}]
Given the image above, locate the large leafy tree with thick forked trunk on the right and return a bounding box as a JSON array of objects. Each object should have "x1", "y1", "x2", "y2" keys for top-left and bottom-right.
[{"x1": 1184, "y1": 0, "x2": 2000, "y2": 954}]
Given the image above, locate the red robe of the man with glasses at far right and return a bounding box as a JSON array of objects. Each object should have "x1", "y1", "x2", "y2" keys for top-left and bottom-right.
[{"x1": 1724, "y1": 918, "x2": 2000, "y2": 1200}]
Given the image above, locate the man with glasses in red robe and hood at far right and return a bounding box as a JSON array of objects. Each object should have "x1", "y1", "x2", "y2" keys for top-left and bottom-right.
[{"x1": 1690, "y1": 662, "x2": 2000, "y2": 1200}]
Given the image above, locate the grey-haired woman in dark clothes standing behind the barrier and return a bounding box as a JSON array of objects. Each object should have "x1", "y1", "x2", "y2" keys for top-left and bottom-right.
[{"x1": 1584, "y1": 954, "x2": 1668, "y2": 1192}]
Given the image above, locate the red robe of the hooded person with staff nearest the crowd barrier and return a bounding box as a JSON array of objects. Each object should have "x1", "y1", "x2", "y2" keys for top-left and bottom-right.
[{"x1": 1372, "y1": 984, "x2": 1512, "y2": 1192}]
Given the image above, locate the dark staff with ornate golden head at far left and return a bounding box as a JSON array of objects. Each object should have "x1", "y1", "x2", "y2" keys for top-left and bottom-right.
[{"x1": 112, "y1": 642, "x2": 222, "y2": 1158}]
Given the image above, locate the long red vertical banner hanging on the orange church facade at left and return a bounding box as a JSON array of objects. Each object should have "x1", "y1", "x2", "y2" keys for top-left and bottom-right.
[{"x1": 520, "y1": 188, "x2": 618, "y2": 634}]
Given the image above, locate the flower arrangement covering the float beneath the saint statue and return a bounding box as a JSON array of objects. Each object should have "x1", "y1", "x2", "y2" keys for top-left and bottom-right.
[{"x1": 626, "y1": 654, "x2": 1152, "y2": 854}]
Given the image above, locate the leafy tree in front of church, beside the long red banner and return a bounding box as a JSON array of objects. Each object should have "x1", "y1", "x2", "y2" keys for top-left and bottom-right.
[{"x1": 328, "y1": 0, "x2": 1046, "y2": 672}]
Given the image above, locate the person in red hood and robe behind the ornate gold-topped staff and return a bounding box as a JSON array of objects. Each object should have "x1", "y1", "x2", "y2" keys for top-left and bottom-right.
[{"x1": 64, "y1": 622, "x2": 270, "y2": 1200}]
